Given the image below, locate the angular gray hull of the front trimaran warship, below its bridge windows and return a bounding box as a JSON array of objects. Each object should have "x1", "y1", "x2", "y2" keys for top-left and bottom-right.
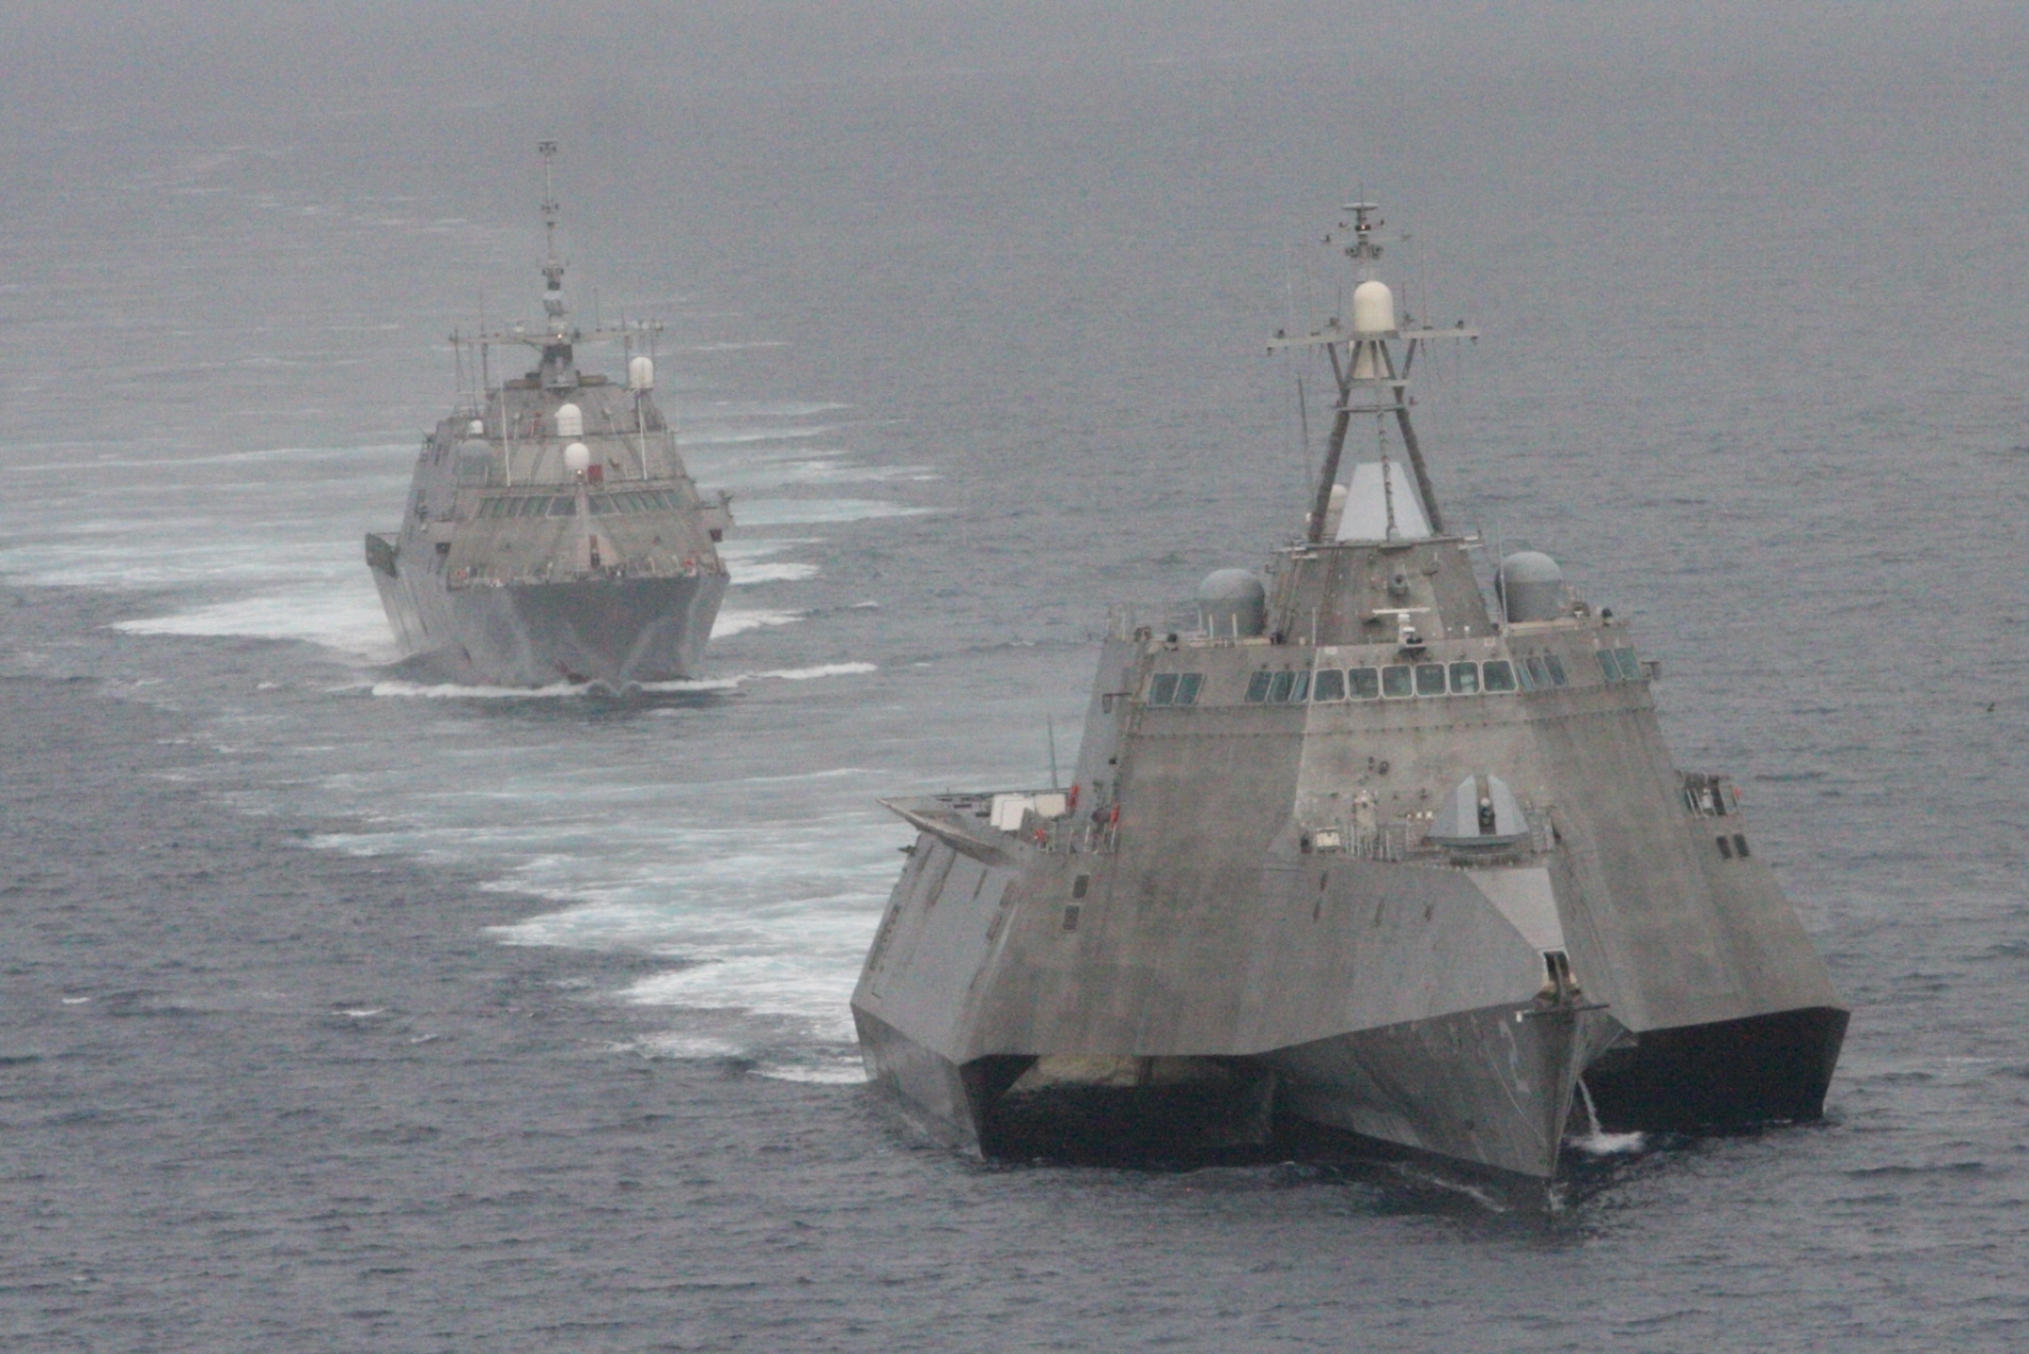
[{"x1": 852, "y1": 588, "x2": 1846, "y2": 1179}]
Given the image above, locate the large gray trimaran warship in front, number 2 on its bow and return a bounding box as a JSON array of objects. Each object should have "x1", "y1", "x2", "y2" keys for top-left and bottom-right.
[{"x1": 852, "y1": 203, "x2": 1848, "y2": 1183}]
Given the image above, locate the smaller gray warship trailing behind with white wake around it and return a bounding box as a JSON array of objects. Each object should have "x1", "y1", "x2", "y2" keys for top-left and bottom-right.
[{"x1": 367, "y1": 142, "x2": 732, "y2": 688}]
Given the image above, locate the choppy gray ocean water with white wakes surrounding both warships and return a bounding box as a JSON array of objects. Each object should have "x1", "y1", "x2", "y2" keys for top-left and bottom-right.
[{"x1": 0, "y1": 4, "x2": 2029, "y2": 1354}]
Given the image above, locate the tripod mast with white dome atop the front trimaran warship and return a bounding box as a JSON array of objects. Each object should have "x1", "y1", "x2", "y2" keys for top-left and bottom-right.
[{"x1": 1268, "y1": 203, "x2": 1479, "y2": 546}]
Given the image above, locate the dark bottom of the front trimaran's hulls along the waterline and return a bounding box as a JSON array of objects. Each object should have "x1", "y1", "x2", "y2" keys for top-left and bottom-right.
[{"x1": 854, "y1": 1007, "x2": 1846, "y2": 1181}]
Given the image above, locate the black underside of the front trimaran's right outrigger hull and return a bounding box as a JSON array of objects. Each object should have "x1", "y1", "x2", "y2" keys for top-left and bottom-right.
[{"x1": 1585, "y1": 1007, "x2": 1846, "y2": 1133}]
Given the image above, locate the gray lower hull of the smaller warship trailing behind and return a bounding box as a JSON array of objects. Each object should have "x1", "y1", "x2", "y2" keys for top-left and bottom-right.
[{"x1": 367, "y1": 538, "x2": 726, "y2": 688}]
